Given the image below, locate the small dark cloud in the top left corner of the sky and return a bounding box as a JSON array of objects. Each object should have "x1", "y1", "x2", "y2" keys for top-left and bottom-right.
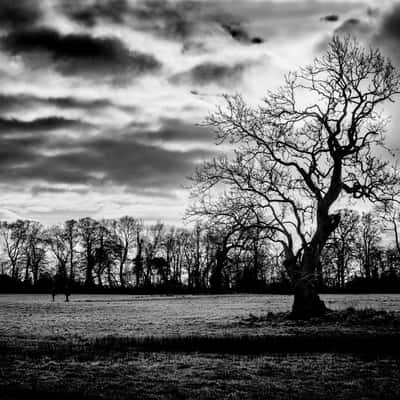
[{"x1": 0, "y1": 0, "x2": 41, "y2": 29}]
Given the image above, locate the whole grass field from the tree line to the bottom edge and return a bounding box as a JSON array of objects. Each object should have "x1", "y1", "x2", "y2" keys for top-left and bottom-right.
[{"x1": 0, "y1": 295, "x2": 400, "y2": 400}]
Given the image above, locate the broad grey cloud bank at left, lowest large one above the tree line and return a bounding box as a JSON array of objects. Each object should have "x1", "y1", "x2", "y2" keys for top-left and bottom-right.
[{"x1": 0, "y1": 120, "x2": 219, "y2": 190}]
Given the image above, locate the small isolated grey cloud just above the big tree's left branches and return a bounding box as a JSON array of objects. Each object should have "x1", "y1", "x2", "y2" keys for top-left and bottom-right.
[{"x1": 170, "y1": 62, "x2": 246, "y2": 86}]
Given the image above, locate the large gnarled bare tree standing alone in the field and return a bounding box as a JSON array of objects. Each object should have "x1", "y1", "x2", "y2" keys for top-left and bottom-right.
[{"x1": 191, "y1": 37, "x2": 400, "y2": 318}]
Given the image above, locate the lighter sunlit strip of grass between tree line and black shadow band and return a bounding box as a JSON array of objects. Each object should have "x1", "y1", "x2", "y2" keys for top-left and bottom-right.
[{"x1": 0, "y1": 294, "x2": 400, "y2": 340}]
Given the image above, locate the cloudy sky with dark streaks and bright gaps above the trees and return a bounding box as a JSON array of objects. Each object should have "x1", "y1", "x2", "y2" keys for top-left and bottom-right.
[{"x1": 0, "y1": 0, "x2": 400, "y2": 224}]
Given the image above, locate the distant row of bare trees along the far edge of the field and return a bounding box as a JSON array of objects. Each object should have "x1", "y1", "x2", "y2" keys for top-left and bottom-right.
[{"x1": 0, "y1": 209, "x2": 400, "y2": 293}]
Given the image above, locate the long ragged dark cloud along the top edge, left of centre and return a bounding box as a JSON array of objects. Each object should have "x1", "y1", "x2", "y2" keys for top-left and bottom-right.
[{"x1": 63, "y1": 0, "x2": 263, "y2": 44}]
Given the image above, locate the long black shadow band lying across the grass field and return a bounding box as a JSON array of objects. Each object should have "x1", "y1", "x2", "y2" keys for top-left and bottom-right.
[{"x1": 0, "y1": 333, "x2": 400, "y2": 361}]
